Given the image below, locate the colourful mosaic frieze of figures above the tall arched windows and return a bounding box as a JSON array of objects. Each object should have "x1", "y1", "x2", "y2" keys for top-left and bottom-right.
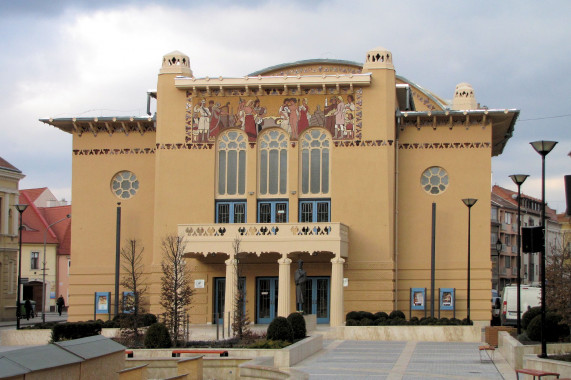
[{"x1": 185, "y1": 88, "x2": 363, "y2": 143}]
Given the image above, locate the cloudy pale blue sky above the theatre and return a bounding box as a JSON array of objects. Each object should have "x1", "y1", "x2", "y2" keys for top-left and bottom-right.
[{"x1": 0, "y1": 0, "x2": 571, "y2": 213}]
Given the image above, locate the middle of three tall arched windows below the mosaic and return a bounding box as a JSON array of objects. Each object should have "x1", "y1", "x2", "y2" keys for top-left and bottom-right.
[{"x1": 258, "y1": 129, "x2": 289, "y2": 195}]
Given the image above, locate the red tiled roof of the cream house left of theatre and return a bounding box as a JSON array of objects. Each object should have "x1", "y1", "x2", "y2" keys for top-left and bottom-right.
[{"x1": 20, "y1": 193, "x2": 71, "y2": 255}]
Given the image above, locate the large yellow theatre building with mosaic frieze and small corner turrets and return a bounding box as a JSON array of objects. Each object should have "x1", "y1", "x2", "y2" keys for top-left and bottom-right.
[{"x1": 41, "y1": 48, "x2": 519, "y2": 326}]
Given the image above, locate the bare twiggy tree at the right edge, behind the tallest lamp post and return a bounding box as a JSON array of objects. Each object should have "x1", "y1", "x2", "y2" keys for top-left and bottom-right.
[{"x1": 545, "y1": 244, "x2": 571, "y2": 325}]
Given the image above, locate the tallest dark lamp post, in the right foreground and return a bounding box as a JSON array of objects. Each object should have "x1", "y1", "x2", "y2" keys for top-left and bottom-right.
[{"x1": 530, "y1": 140, "x2": 557, "y2": 358}]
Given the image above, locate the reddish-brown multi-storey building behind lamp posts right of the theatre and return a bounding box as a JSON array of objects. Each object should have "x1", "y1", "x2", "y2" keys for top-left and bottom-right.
[{"x1": 491, "y1": 185, "x2": 561, "y2": 291}]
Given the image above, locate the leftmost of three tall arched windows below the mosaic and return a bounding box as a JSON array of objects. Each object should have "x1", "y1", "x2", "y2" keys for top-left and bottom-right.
[{"x1": 217, "y1": 131, "x2": 247, "y2": 195}]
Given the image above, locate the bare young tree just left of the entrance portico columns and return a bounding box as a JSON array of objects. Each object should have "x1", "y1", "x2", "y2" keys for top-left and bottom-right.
[{"x1": 160, "y1": 235, "x2": 193, "y2": 346}]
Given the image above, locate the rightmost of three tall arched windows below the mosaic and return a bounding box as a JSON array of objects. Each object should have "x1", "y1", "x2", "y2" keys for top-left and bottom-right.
[{"x1": 300, "y1": 128, "x2": 331, "y2": 194}]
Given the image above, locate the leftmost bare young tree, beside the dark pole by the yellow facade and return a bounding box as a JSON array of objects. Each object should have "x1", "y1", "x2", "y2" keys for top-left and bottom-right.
[{"x1": 121, "y1": 239, "x2": 147, "y2": 345}]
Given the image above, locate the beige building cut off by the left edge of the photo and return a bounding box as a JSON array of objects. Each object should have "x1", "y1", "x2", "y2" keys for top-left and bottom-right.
[{"x1": 0, "y1": 157, "x2": 25, "y2": 321}]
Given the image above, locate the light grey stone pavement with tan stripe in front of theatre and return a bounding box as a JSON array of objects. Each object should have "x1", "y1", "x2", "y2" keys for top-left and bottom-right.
[{"x1": 294, "y1": 340, "x2": 516, "y2": 380}]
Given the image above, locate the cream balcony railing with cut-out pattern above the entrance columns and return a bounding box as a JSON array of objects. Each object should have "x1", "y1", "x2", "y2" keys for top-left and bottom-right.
[{"x1": 178, "y1": 223, "x2": 349, "y2": 257}]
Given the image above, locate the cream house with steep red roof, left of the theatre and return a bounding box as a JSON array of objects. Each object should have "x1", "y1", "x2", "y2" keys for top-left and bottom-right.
[{"x1": 20, "y1": 188, "x2": 71, "y2": 312}]
